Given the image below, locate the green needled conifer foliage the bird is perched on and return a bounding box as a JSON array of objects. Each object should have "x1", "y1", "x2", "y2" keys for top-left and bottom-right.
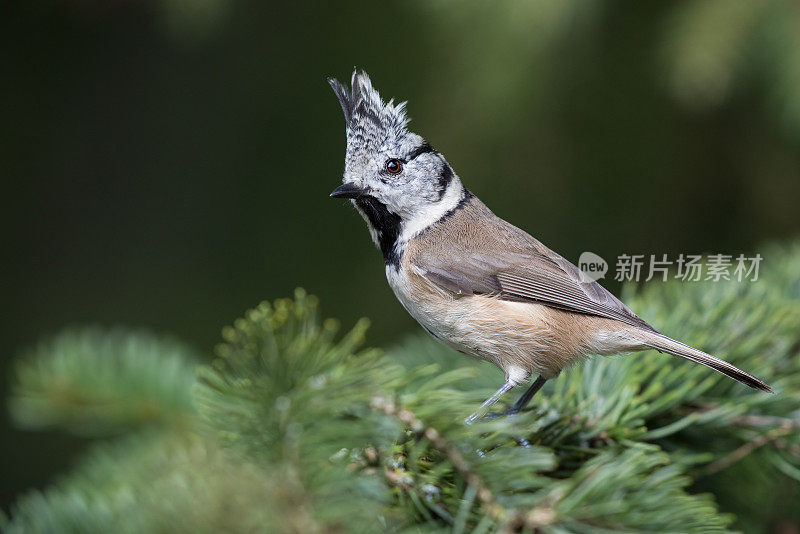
[{"x1": 0, "y1": 245, "x2": 800, "y2": 533}]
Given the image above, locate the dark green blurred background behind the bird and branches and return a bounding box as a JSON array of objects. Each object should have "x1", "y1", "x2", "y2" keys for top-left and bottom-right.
[{"x1": 0, "y1": 0, "x2": 800, "y2": 509}]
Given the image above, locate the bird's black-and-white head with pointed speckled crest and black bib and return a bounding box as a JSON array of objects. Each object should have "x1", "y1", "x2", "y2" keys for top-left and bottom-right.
[{"x1": 328, "y1": 71, "x2": 466, "y2": 262}]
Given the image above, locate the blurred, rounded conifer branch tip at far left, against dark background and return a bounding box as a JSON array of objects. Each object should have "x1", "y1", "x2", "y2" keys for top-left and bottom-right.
[{"x1": 10, "y1": 328, "x2": 197, "y2": 435}]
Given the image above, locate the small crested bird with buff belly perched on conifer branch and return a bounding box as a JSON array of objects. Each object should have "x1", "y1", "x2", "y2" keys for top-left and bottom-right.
[{"x1": 328, "y1": 69, "x2": 772, "y2": 423}]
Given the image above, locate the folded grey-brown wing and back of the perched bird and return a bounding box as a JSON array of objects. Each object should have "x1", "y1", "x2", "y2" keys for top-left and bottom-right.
[{"x1": 410, "y1": 199, "x2": 655, "y2": 332}]
